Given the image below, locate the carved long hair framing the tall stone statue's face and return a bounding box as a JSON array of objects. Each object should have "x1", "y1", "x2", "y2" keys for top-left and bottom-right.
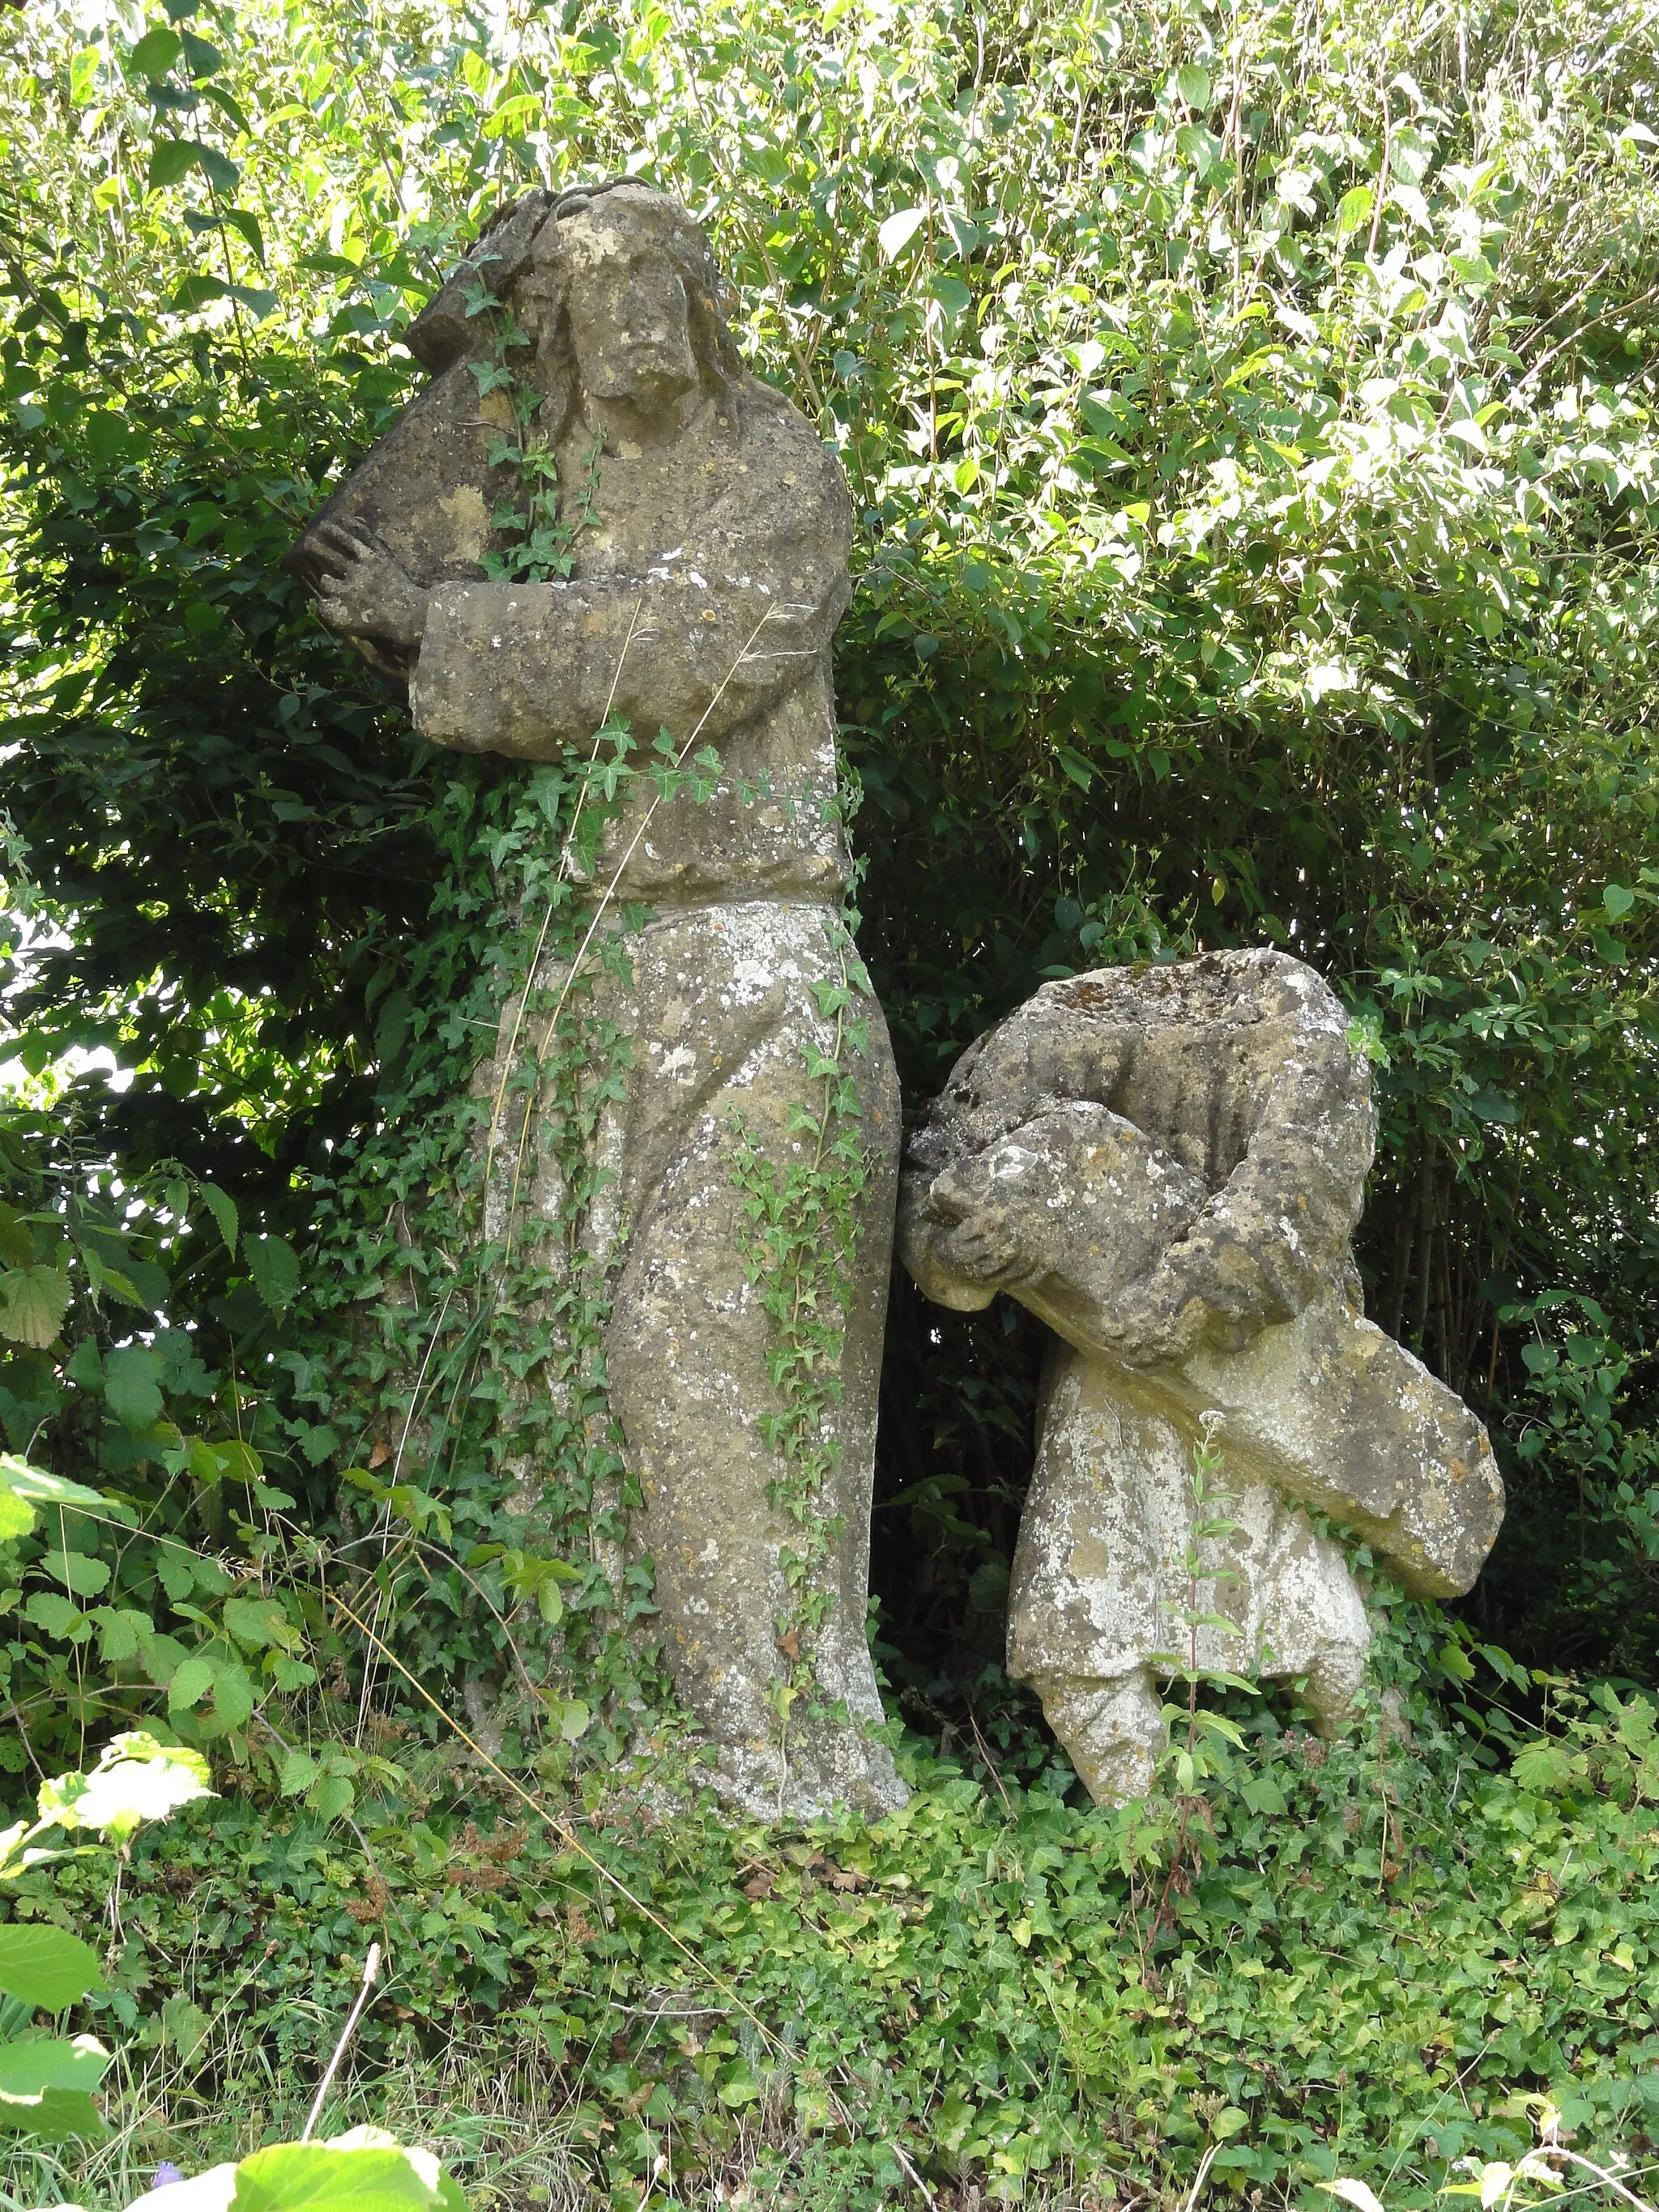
[{"x1": 405, "y1": 177, "x2": 750, "y2": 433}]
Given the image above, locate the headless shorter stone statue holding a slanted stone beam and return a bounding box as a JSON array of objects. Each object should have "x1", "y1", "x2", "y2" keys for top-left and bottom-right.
[{"x1": 898, "y1": 951, "x2": 1504, "y2": 1803}]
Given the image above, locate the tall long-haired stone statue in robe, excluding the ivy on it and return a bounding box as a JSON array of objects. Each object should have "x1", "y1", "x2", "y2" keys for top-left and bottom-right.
[{"x1": 290, "y1": 181, "x2": 907, "y2": 1816}]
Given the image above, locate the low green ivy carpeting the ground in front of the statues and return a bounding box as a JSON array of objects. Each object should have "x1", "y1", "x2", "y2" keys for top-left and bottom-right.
[{"x1": 0, "y1": 1636, "x2": 1659, "y2": 2206}]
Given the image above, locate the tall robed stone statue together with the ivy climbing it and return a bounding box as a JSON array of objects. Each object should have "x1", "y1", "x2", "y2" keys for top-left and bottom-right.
[{"x1": 292, "y1": 181, "x2": 905, "y2": 1816}]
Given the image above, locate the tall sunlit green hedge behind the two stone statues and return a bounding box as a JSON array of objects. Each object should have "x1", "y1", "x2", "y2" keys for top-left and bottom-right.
[{"x1": 4, "y1": 0, "x2": 1657, "y2": 1673}]
